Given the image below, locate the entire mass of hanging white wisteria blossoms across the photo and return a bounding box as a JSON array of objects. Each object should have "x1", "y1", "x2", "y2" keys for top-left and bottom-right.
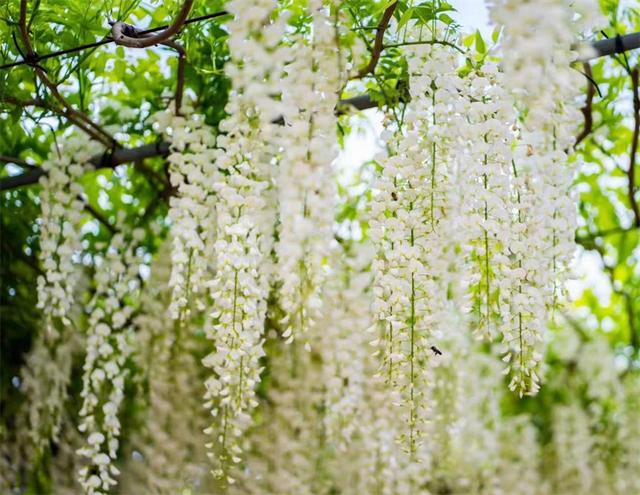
[{"x1": 0, "y1": 0, "x2": 640, "y2": 495}]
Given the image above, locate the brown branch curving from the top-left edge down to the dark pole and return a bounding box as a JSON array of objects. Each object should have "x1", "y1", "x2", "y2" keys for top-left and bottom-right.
[{"x1": 19, "y1": 0, "x2": 117, "y2": 147}]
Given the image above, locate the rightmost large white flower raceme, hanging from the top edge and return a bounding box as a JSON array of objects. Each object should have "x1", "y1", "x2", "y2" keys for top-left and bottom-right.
[{"x1": 491, "y1": 0, "x2": 599, "y2": 396}]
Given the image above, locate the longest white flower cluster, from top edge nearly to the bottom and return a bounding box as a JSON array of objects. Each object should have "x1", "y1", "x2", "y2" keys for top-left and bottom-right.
[{"x1": 204, "y1": 0, "x2": 286, "y2": 483}]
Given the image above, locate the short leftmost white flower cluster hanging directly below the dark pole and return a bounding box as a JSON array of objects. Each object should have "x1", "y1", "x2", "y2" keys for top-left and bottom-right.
[{"x1": 38, "y1": 136, "x2": 96, "y2": 328}]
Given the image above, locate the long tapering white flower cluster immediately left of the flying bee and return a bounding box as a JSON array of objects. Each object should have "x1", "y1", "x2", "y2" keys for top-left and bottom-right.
[{"x1": 370, "y1": 40, "x2": 461, "y2": 454}]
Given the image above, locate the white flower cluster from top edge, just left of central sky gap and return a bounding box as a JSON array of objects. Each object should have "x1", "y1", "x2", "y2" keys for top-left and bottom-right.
[{"x1": 275, "y1": 0, "x2": 340, "y2": 342}]
